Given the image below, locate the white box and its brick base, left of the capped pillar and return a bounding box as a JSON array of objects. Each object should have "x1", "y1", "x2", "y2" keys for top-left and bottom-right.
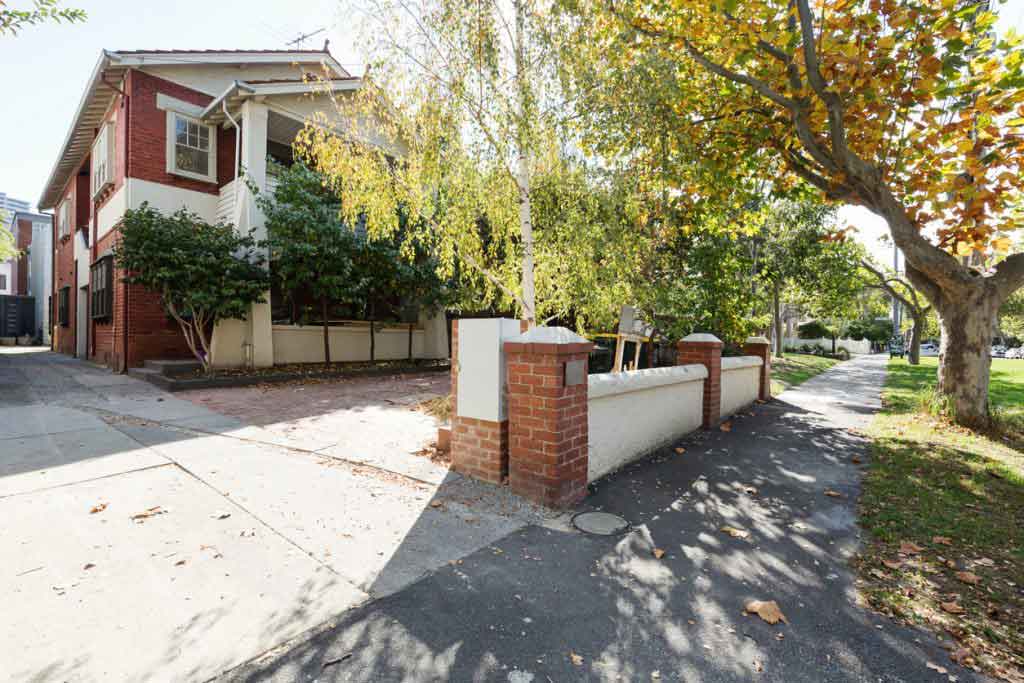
[{"x1": 451, "y1": 318, "x2": 523, "y2": 484}]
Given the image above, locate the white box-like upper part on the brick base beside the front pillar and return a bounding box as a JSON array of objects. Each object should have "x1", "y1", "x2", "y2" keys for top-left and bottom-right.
[{"x1": 456, "y1": 317, "x2": 519, "y2": 422}]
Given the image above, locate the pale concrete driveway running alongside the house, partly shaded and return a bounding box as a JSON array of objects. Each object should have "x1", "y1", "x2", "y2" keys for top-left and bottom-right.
[{"x1": 0, "y1": 347, "x2": 540, "y2": 681}]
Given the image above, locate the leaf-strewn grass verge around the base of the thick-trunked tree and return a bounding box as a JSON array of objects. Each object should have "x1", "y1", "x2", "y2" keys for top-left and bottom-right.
[{"x1": 857, "y1": 358, "x2": 1024, "y2": 682}]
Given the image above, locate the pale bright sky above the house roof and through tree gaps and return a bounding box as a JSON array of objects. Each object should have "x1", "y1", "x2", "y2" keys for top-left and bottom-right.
[{"x1": 0, "y1": 0, "x2": 1024, "y2": 261}]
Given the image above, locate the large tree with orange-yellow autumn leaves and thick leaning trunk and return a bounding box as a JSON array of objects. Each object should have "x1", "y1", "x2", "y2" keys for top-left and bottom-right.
[{"x1": 569, "y1": 0, "x2": 1024, "y2": 426}]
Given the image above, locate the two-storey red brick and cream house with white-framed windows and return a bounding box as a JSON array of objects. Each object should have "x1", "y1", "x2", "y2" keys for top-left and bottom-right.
[{"x1": 39, "y1": 50, "x2": 447, "y2": 371}]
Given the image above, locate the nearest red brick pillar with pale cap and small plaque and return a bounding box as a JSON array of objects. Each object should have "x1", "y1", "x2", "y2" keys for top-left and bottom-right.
[{"x1": 505, "y1": 328, "x2": 594, "y2": 508}]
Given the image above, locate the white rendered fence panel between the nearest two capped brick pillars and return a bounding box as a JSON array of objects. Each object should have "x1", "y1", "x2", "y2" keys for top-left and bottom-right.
[{"x1": 589, "y1": 366, "x2": 708, "y2": 481}]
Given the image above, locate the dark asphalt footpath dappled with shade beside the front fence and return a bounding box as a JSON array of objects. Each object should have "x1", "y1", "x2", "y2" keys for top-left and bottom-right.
[{"x1": 223, "y1": 356, "x2": 981, "y2": 683}]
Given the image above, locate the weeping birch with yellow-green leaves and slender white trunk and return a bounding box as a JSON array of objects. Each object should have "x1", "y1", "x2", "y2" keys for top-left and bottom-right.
[{"x1": 301, "y1": 0, "x2": 593, "y2": 325}]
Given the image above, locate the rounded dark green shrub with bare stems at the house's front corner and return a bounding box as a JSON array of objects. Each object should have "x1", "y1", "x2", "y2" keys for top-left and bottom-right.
[{"x1": 114, "y1": 203, "x2": 268, "y2": 372}]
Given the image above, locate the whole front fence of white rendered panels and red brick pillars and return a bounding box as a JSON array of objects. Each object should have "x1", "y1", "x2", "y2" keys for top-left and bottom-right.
[{"x1": 452, "y1": 319, "x2": 771, "y2": 507}]
